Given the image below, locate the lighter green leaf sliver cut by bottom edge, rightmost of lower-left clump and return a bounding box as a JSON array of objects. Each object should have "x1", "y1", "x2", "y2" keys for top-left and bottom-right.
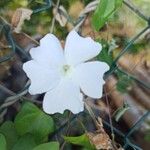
[{"x1": 33, "y1": 142, "x2": 59, "y2": 150}]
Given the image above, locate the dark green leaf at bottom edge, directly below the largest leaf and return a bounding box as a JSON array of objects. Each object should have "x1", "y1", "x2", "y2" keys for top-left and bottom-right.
[{"x1": 12, "y1": 134, "x2": 37, "y2": 150}]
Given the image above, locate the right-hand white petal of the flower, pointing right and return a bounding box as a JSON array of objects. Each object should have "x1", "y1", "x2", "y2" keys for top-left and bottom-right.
[{"x1": 73, "y1": 61, "x2": 109, "y2": 98}]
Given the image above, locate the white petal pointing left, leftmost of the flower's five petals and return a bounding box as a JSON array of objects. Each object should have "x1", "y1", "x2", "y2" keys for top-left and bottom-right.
[{"x1": 23, "y1": 60, "x2": 60, "y2": 95}]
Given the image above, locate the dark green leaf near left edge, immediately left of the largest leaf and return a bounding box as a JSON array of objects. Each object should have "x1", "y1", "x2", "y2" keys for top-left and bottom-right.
[{"x1": 0, "y1": 121, "x2": 18, "y2": 150}]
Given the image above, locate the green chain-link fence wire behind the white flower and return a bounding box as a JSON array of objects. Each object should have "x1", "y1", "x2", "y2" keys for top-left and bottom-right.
[{"x1": 0, "y1": 0, "x2": 150, "y2": 150}]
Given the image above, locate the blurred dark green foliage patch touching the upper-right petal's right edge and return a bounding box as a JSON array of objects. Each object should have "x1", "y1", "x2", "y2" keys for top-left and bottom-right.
[{"x1": 97, "y1": 40, "x2": 113, "y2": 66}]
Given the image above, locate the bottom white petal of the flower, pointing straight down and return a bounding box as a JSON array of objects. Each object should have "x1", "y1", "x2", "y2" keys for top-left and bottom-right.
[{"x1": 43, "y1": 78, "x2": 84, "y2": 114}]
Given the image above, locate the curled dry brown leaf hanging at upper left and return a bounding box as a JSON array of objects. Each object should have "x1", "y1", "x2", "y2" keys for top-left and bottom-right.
[{"x1": 11, "y1": 8, "x2": 33, "y2": 33}]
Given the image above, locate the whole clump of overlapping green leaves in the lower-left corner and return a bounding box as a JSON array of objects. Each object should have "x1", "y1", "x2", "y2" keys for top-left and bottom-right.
[{"x1": 0, "y1": 102, "x2": 59, "y2": 150}]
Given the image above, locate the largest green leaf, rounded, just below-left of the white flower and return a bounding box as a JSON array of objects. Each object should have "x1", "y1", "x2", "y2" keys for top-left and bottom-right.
[{"x1": 15, "y1": 102, "x2": 54, "y2": 143}]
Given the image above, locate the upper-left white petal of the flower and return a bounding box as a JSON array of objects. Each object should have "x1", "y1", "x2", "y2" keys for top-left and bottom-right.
[{"x1": 30, "y1": 34, "x2": 64, "y2": 66}]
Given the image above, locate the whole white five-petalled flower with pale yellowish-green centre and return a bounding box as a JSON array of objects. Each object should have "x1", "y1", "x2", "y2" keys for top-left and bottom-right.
[{"x1": 23, "y1": 30, "x2": 109, "y2": 114}]
